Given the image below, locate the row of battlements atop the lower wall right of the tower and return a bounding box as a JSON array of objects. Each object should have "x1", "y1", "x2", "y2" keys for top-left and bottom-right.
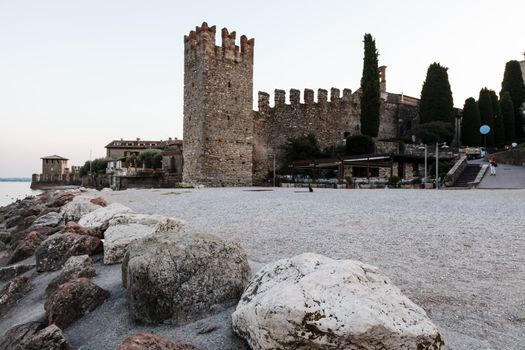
[{"x1": 258, "y1": 88, "x2": 352, "y2": 111}]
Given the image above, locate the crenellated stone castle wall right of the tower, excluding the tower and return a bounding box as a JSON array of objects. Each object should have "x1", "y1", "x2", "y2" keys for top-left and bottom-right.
[{"x1": 253, "y1": 88, "x2": 410, "y2": 183}]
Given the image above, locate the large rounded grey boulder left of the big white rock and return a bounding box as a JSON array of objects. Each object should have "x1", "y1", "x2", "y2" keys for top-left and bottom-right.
[{"x1": 122, "y1": 233, "x2": 250, "y2": 324}]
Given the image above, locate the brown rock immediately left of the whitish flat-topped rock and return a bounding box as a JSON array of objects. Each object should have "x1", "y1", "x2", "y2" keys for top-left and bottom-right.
[{"x1": 35, "y1": 233, "x2": 102, "y2": 272}]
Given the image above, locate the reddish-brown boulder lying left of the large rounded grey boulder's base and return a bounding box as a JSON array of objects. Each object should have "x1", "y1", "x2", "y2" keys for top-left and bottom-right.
[{"x1": 44, "y1": 277, "x2": 109, "y2": 328}]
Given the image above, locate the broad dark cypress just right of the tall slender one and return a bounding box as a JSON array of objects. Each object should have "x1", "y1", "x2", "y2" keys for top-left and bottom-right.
[{"x1": 419, "y1": 63, "x2": 454, "y2": 126}]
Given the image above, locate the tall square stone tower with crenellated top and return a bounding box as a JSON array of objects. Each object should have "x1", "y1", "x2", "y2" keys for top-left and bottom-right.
[{"x1": 183, "y1": 22, "x2": 254, "y2": 186}]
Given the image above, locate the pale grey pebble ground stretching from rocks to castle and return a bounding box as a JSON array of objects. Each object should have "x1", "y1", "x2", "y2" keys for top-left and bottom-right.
[{"x1": 104, "y1": 188, "x2": 525, "y2": 350}]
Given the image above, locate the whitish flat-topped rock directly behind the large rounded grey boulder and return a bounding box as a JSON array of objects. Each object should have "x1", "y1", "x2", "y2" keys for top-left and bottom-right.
[{"x1": 104, "y1": 213, "x2": 185, "y2": 264}]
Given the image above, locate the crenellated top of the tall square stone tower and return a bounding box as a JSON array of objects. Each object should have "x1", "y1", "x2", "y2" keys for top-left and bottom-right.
[{"x1": 184, "y1": 22, "x2": 255, "y2": 62}]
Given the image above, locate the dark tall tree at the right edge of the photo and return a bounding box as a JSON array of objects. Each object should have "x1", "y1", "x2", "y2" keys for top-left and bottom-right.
[{"x1": 500, "y1": 61, "x2": 525, "y2": 139}]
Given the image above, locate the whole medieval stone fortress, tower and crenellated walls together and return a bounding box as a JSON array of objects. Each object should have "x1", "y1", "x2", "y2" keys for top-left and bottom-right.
[{"x1": 183, "y1": 23, "x2": 419, "y2": 186}]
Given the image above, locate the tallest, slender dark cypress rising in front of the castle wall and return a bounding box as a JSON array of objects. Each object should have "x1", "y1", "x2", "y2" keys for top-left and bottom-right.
[{"x1": 361, "y1": 34, "x2": 380, "y2": 137}]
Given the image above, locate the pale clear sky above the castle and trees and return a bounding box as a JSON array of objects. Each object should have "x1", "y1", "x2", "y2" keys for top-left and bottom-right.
[{"x1": 0, "y1": 0, "x2": 525, "y2": 177}]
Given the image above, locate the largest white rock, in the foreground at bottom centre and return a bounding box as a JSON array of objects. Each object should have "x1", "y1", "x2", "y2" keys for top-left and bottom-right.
[{"x1": 232, "y1": 253, "x2": 444, "y2": 350}]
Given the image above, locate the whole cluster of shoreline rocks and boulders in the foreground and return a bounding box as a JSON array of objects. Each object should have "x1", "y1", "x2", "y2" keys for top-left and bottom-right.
[{"x1": 0, "y1": 191, "x2": 444, "y2": 350}]
